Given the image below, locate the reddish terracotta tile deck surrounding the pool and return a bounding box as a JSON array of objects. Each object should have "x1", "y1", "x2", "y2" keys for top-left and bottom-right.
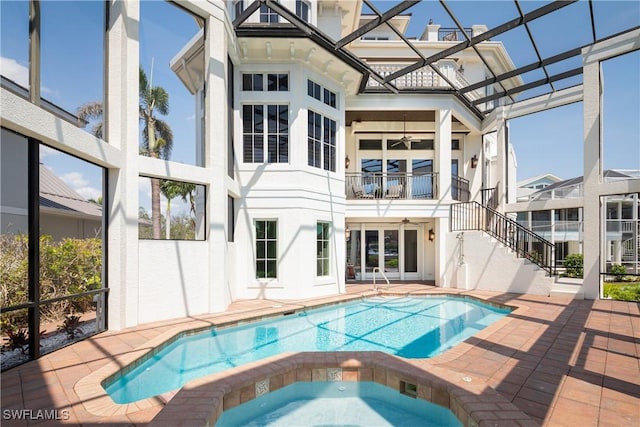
[{"x1": 0, "y1": 283, "x2": 640, "y2": 427}]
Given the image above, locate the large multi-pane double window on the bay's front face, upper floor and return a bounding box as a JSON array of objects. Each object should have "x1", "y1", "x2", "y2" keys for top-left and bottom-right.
[{"x1": 242, "y1": 105, "x2": 289, "y2": 163}]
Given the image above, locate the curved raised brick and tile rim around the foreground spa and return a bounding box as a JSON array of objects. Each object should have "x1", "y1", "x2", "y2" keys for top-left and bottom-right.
[{"x1": 149, "y1": 352, "x2": 536, "y2": 427}]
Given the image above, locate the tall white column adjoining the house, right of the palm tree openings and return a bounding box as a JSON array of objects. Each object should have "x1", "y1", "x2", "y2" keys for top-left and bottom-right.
[{"x1": 202, "y1": 16, "x2": 232, "y2": 312}]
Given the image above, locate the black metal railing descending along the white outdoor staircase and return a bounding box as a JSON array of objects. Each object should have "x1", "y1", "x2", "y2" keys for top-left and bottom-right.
[{"x1": 450, "y1": 201, "x2": 556, "y2": 275}]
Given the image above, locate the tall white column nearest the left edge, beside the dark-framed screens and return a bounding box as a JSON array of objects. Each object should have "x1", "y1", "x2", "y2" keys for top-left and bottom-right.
[{"x1": 105, "y1": 2, "x2": 140, "y2": 330}]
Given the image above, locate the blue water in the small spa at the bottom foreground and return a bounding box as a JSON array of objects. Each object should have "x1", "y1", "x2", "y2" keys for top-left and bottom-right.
[{"x1": 216, "y1": 381, "x2": 462, "y2": 427}]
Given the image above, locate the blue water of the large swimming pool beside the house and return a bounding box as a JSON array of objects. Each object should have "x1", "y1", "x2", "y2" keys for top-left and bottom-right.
[{"x1": 105, "y1": 297, "x2": 510, "y2": 403}]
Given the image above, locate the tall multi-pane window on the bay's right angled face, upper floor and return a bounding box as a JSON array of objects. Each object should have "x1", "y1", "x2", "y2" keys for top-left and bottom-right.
[{"x1": 307, "y1": 110, "x2": 336, "y2": 172}]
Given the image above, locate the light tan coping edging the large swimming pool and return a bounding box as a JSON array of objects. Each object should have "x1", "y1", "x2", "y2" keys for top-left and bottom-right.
[{"x1": 74, "y1": 290, "x2": 526, "y2": 425}]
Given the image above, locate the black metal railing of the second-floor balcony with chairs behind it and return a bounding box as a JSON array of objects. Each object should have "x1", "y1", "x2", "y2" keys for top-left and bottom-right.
[{"x1": 345, "y1": 172, "x2": 469, "y2": 202}]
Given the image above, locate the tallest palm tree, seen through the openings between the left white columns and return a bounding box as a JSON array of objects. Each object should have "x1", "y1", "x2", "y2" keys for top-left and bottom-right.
[{"x1": 76, "y1": 68, "x2": 173, "y2": 239}]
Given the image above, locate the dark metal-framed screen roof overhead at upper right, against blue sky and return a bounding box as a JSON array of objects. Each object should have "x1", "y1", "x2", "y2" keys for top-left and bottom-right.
[{"x1": 233, "y1": 0, "x2": 640, "y2": 118}]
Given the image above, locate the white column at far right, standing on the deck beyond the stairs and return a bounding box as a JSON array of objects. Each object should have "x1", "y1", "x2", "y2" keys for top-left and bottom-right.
[{"x1": 582, "y1": 50, "x2": 602, "y2": 299}]
